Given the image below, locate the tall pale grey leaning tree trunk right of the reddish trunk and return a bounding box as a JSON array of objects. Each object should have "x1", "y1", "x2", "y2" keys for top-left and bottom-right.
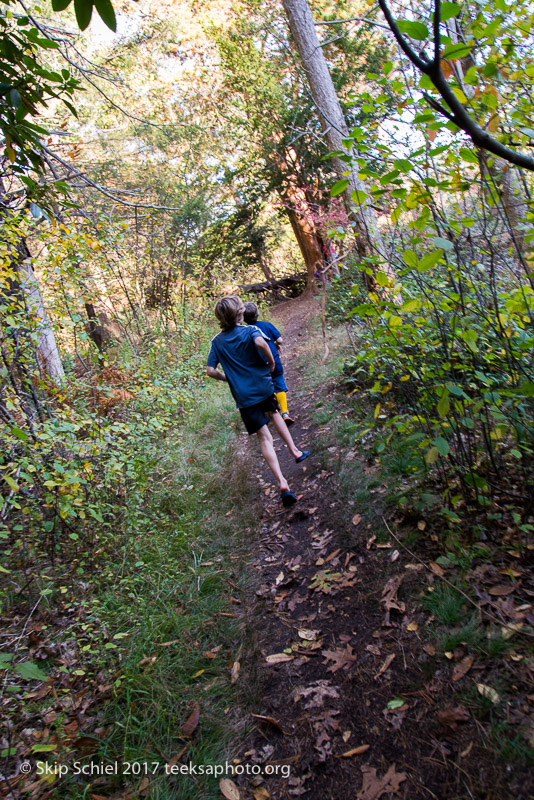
[{"x1": 282, "y1": 0, "x2": 387, "y2": 269}]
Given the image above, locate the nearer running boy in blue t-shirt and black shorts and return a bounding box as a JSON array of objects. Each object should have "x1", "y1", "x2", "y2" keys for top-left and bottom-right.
[{"x1": 206, "y1": 295, "x2": 310, "y2": 507}]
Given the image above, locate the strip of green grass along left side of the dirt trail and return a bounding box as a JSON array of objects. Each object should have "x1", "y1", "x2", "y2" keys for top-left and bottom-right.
[{"x1": 61, "y1": 385, "x2": 257, "y2": 800}]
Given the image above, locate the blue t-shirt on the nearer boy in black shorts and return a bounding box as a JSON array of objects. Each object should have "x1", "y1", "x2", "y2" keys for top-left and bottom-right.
[{"x1": 207, "y1": 325, "x2": 274, "y2": 408}]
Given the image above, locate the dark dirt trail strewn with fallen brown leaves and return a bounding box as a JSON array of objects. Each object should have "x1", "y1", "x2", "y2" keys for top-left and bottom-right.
[{"x1": 232, "y1": 301, "x2": 529, "y2": 800}]
